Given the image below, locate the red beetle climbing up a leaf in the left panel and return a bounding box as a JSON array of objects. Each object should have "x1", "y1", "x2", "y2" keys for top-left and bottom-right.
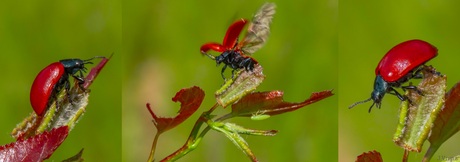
[{"x1": 30, "y1": 59, "x2": 92, "y2": 116}]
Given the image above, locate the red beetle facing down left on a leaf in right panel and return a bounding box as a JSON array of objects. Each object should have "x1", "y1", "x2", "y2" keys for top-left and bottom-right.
[{"x1": 349, "y1": 39, "x2": 438, "y2": 112}]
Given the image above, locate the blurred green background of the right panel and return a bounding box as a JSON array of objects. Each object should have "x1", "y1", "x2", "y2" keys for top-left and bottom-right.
[{"x1": 338, "y1": 0, "x2": 460, "y2": 161}]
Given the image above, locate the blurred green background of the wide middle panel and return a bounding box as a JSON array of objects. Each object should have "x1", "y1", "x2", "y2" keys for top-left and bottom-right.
[{"x1": 122, "y1": 0, "x2": 338, "y2": 161}]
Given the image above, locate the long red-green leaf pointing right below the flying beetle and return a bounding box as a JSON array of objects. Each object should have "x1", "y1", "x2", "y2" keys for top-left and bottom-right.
[{"x1": 232, "y1": 90, "x2": 334, "y2": 117}]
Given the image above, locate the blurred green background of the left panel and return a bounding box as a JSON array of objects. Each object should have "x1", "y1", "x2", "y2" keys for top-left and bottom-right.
[{"x1": 0, "y1": 0, "x2": 122, "y2": 161}]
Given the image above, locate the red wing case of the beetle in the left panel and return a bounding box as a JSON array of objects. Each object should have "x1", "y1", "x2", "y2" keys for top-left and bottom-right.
[{"x1": 30, "y1": 62, "x2": 65, "y2": 116}]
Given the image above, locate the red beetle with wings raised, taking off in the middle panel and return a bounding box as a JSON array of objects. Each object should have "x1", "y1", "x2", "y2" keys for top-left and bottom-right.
[{"x1": 200, "y1": 3, "x2": 275, "y2": 80}]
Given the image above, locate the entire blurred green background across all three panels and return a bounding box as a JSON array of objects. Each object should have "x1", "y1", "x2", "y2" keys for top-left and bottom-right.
[{"x1": 0, "y1": 0, "x2": 460, "y2": 161}]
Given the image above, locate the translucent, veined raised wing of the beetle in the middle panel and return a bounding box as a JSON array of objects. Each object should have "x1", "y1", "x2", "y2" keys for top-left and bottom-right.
[{"x1": 238, "y1": 3, "x2": 276, "y2": 55}]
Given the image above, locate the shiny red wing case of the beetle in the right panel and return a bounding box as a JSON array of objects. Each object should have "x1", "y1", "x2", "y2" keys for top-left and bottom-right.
[{"x1": 375, "y1": 39, "x2": 438, "y2": 82}]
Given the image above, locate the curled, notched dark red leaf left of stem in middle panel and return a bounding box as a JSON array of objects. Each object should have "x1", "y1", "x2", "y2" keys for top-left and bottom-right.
[{"x1": 147, "y1": 86, "x2": 204, "y2": 133}]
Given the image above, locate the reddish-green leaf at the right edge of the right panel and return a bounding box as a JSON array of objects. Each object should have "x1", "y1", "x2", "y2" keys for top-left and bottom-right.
[{"x1": 425, "y1": 82, "x2": 460, "y2": 159}]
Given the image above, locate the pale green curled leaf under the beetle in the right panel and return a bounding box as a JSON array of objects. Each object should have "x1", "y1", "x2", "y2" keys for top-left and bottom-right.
[{"x1": 393, "y1": 67, "x2": 447, "y2": 152}]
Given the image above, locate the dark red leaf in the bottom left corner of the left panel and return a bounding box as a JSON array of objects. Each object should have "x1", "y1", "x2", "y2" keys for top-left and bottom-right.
[{"x1": 0, "y1": 126, "x2": 69, "y2": 161}]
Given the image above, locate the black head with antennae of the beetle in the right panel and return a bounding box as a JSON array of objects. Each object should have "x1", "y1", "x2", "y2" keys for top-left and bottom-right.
[{"x1": 348, "y1": 75, "x2": 388, "y2": 113}]
